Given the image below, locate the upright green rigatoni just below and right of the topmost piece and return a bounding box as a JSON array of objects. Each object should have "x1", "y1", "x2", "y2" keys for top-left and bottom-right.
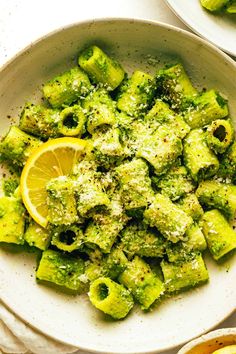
[{"x1": 117, "y1": 71, "x2": 156, "y2": 117}]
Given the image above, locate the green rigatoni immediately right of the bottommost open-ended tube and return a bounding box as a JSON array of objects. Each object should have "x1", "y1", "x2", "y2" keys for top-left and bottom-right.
[{"x1": 119, "y1": 256, "x2": 164, "y2": 310}]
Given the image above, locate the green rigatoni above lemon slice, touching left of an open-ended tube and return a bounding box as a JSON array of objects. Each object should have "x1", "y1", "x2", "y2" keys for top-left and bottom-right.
[{"x1": 19, "y1": 103, "x2": 61, "y2": 139}]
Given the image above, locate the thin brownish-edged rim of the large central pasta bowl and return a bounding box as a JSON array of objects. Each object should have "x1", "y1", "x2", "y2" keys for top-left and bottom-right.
[{"x1": 0, "y1": 17, "x2": 236, "y2": 354}]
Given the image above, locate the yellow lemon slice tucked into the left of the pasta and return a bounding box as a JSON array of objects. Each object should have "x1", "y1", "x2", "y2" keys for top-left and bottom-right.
[{"x1": 20, "y1": 137, "x2": 87, "y2": 227}]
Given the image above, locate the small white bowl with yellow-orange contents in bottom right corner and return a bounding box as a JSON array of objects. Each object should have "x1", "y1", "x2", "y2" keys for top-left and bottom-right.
[{"x1": 178, "y1": 328, "x2": 236, "y2": 354}]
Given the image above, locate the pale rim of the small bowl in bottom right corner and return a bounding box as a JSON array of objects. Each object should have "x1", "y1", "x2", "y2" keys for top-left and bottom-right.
[{"x1": 177, "y1": 327, "x2": 236, "y2": 354}]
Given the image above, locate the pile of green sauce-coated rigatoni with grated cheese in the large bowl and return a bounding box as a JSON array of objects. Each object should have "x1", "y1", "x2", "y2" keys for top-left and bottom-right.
[{"x1": 0, "y1": 45, "x2": 236, "y2": 319}]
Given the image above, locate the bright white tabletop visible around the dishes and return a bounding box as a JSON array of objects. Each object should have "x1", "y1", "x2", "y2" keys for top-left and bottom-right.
[{"x1": 0, "y1": 0, "x2": 236, "y2": 354}]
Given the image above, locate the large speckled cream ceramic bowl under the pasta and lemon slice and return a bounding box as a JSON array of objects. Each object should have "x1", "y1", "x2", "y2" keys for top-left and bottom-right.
[{"x1": 0, "y1": 19, "x2": 236, "y2": 354}]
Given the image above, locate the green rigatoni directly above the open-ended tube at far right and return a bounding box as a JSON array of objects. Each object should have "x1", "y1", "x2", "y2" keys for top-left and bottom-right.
[{"x1": 184, "y1": 90, "x2": 229, "y2": 129}]
